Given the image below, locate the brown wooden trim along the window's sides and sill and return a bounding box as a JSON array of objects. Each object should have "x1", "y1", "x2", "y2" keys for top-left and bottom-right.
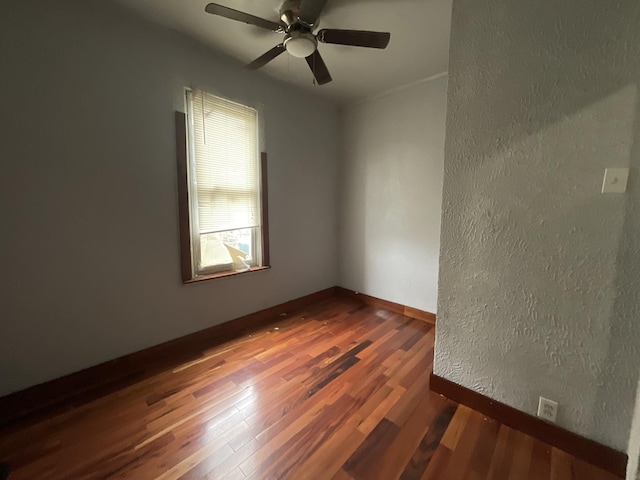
[{"x1": 175, "y1": 111, "x2": 271, "y2": 284}]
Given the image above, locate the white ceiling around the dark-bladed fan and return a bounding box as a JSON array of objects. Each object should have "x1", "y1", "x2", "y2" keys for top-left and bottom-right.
[{"x1": 117, "y1": 0, "x2": 452, "y2": 103}]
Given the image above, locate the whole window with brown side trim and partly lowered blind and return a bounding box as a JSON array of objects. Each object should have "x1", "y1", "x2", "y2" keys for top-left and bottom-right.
[{"x1": 176, "y1": 90, "x2": 268, "y2": 282}]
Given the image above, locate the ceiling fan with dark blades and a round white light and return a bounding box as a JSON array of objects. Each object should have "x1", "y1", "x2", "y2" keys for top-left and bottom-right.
[{"x1": 205, "y1": 0, "x2": 391, "y2": 85}]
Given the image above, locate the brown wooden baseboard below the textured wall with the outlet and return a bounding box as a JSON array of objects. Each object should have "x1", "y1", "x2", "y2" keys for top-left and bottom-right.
[{"x1": 430, "y1": 373, "x2": 627, "y2": 478}]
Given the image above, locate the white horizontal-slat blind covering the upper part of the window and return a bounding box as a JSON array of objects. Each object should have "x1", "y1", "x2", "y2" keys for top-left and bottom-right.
[{"x1": 188, "y1": 90, "x2": 260, "y2": 233}]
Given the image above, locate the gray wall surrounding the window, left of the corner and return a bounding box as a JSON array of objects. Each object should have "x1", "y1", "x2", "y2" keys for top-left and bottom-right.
[{"x1": 0, "y1": 0, "x2": 339, "y2": 395}]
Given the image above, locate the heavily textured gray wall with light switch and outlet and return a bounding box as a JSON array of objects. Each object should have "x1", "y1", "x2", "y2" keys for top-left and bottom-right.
[{"x1": 434, "y1": 0, "x2": 640, "y2": 450}]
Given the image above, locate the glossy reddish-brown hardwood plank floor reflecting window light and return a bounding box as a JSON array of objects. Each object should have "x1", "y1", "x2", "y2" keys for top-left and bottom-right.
[{"x1": 0, "y1": 297, "x2": 617, "y2": 480}]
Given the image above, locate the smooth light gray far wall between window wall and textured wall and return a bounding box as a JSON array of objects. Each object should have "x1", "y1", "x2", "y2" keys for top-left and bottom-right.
[{"x1": 339, "y1": 76, "x2": 447, "y2": 313}]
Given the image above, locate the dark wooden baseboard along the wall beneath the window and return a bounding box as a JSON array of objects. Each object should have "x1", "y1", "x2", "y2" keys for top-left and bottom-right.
[{"x1": 0, "y1": 287, "x2": 337, "y2": 428}]
